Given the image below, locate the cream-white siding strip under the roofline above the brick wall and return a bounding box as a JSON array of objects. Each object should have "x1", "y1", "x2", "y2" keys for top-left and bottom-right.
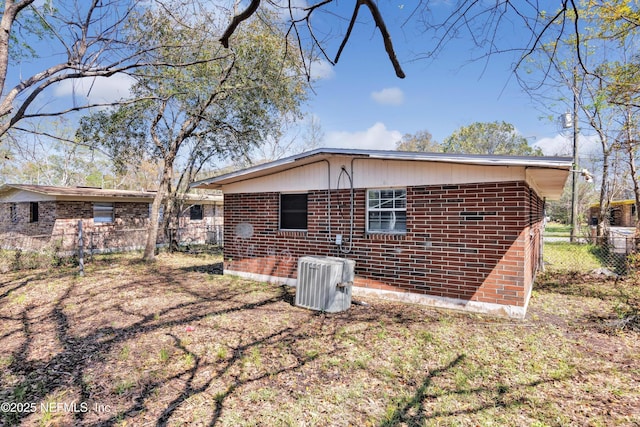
[{"x1": 224, "y1": 156, "x2": 528, "y2": 193}]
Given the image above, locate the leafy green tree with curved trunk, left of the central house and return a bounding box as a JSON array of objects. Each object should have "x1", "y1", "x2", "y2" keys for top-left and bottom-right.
[{"x1": 77, "y1": 5, "x2": 307, "y2": 261}]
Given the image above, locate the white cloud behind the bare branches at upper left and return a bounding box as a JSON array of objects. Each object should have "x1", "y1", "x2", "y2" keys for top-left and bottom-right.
[{"x1": 54, "y1": 74, "x2": 135, "y2": 103}]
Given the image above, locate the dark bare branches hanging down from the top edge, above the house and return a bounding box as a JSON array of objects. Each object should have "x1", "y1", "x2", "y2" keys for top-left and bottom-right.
[{"x1": 220, "y1": 0, "x2": 608, "y2": 78}]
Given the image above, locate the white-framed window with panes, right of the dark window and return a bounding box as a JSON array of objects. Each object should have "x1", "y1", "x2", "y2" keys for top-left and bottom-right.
[{"x1": 367, "y1": 188, "x2": 407, "y2": 233}]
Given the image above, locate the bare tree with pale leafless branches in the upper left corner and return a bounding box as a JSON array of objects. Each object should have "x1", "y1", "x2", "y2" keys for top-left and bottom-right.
[{"x1": 0, "y1": 0, "x2": 232, "y2": 137}]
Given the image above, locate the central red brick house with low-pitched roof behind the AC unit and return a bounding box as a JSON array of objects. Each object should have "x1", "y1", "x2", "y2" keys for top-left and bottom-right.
[{"x1": 193, "y1": 149, "x2": 571, "y2": 317}]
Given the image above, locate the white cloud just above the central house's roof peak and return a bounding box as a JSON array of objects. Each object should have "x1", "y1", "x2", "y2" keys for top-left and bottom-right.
[{"x1": 322, "y1": 122, "x2": 402, "y2": 150}]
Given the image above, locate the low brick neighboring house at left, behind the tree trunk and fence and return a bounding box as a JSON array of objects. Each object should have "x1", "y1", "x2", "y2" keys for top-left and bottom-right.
[{"x1": 0, "y1": 184, "x2": 223, "y2": 251}]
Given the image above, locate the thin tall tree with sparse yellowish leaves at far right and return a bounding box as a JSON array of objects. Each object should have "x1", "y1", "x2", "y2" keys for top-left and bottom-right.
[{"x1": 519, "y1": 2, "x2": 640, "y2": 237}]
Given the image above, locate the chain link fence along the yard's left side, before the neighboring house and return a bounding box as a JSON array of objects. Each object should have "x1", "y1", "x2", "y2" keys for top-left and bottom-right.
[{"x1": 0, "y1": 225, "x2": 224, "y2": 273}]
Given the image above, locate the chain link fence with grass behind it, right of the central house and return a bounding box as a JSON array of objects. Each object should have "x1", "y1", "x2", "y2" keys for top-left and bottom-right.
[{"x1": 543, "y1": 229, "x2": 640, "y2": 275}]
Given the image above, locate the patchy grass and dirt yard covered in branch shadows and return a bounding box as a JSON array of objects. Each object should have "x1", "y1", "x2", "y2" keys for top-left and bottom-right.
[{"x1": 0, "y1": 255, "x2": 640, "y2": 426}]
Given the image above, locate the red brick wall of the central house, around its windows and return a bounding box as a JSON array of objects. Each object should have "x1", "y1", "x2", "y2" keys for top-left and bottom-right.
[{"x1": 225, "y1": 182, "x2": 542, "y2": 306}]
